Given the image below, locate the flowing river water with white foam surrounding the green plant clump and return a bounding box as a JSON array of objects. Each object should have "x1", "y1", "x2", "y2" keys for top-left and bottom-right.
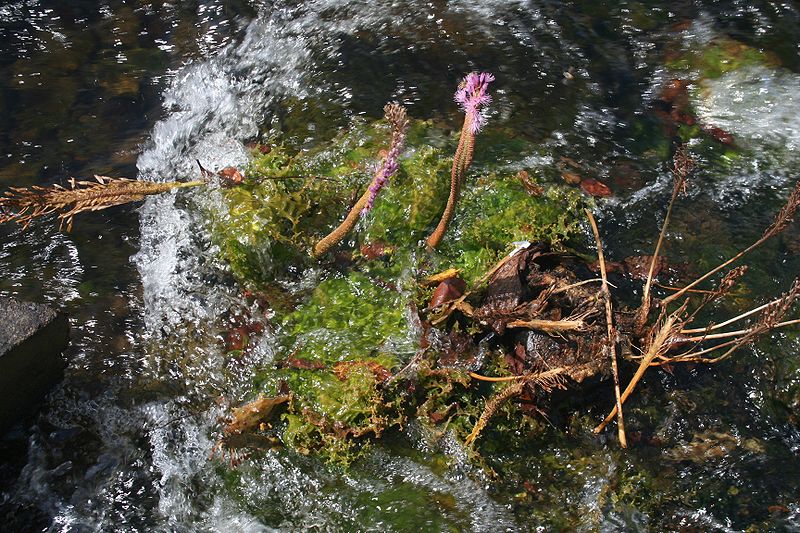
[{"x1": 0, "y1": 0, "x2": 800, "y2": 532}]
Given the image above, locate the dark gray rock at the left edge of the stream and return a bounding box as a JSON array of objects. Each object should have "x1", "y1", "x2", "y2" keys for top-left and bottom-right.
[{"x1": 0, "y1": 296, "x2": 69, "y2": 434}]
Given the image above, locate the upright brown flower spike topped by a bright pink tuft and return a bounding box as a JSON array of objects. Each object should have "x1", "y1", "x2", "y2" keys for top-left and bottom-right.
[{"x1": 426, "y1": 72, "x2": 494, "y2": 249}]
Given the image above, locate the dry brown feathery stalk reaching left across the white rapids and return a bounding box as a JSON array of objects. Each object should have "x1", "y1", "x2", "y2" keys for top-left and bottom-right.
[{"x1": 0, "y1": 176, "x2": 206, "y2": 231}]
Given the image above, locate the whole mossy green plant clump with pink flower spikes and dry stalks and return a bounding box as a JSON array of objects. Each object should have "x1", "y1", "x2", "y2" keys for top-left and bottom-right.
[{"x1": 0, "y1": 73, "x2": 800, "y2": 470}]
